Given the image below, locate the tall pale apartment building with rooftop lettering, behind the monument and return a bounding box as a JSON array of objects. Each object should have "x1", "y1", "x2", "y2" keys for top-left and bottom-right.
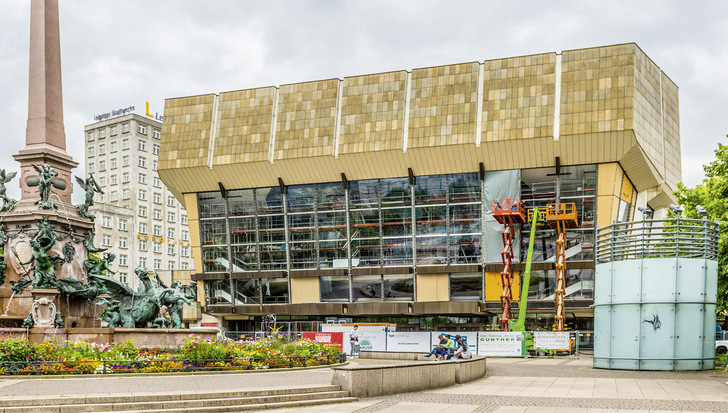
[{"x1": 84, "y1": 113, "x2": 194, "y2": 287}]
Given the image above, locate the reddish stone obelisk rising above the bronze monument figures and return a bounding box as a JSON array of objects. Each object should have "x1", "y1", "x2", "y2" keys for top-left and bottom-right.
[{"x1": 13, "y1": 0, "x2": 78, "y2": 205}]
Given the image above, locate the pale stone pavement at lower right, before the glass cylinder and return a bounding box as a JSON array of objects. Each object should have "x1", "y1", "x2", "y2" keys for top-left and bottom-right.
[{"x1": 269, "y1": 358, "x2": 728, "y2": 413}]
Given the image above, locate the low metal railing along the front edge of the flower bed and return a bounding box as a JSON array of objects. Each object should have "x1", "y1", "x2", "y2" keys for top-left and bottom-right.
[{"x1": 0, "y1": 354, "x2": 346, "y2": 376}]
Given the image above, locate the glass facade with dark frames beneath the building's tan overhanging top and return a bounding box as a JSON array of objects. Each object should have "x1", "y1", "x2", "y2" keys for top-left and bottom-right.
[{"x1": 198, "y1": 165, "x2": 596, "y2": 304}]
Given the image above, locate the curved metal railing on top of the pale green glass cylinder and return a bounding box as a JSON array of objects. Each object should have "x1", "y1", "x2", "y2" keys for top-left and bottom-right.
[{"x1": 596, "y1": 218, "x2": 720, "y2": 263}]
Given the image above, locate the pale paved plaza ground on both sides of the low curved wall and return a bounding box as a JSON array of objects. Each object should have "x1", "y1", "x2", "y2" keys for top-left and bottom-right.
[{"x1": 0, "y1": 358, "x2": 728, "y2": 413}]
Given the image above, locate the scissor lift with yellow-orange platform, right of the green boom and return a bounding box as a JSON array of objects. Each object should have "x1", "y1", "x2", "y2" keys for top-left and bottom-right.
[{"x1": 546, "y1": 202, "x2": 579, "y2": 331}]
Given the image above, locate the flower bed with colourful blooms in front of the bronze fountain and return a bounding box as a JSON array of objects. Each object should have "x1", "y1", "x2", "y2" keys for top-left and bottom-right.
[{"x1": 0, "y1": 335, "x2": 341, "y2": 375}]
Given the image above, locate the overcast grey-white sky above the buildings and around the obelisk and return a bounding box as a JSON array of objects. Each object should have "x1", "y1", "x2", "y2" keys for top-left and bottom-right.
[{"x1": 0, "y1": 0, "x2": 728, "y2": 199}]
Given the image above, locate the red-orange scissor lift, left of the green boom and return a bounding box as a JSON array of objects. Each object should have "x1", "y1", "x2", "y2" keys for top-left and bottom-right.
[{"x1": 493, "y1": 198, "x2": 526, "y2": 331}]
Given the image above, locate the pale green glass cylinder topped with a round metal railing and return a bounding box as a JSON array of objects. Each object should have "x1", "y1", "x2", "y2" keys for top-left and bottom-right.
[{"x1": 594, "y1": 219, "x2": 718, "y2": 370}]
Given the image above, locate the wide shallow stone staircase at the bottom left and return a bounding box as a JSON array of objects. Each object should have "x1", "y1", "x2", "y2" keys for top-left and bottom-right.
[{"x1": 0, "y1": 385, "x2": 358, "y2": 413}]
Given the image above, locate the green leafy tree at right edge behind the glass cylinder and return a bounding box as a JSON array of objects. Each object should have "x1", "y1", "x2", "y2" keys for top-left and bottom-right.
[{"x1": 675, "y1": 137, "x2": 728, "y2": 314}]
